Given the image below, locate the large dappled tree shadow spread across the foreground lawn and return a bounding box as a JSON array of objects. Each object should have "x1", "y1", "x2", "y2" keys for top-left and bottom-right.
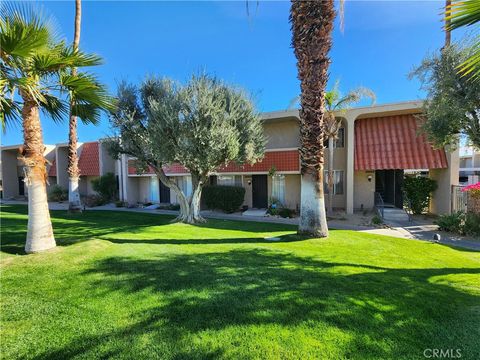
[{"x1": 35, "y1": 249, "x2": 480, "y2": 359}]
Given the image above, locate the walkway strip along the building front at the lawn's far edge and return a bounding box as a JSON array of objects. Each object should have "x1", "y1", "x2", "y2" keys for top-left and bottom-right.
[{"x1": 0, "y1": 200, "x2": 480, "y2": 251}]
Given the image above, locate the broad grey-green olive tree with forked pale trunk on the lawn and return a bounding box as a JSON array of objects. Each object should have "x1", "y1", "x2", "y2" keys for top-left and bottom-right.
[{"x1": 110, "y1": 75, "x2": 265, "y2": 223}]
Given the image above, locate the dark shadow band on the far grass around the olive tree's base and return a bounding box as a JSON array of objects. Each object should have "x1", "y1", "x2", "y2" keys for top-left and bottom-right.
[{"x1": 1, "y1": 205, "x2": 300, "y2": 254}]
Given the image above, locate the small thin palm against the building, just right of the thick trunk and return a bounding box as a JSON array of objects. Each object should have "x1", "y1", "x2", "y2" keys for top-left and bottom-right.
[{"x1": 323, "y1": 81, "x2": 375, "y2": 214}]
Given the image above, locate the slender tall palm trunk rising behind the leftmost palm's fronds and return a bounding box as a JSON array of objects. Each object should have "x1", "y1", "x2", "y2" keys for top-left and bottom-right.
[{"x1": 68, "y1": 0, "x2": 82, "y2": 212}]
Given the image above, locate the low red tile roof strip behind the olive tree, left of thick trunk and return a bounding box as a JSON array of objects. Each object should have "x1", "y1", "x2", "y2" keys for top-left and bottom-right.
[{"x1": 128, "y1": 150, "x2": 300, "y2": 175}]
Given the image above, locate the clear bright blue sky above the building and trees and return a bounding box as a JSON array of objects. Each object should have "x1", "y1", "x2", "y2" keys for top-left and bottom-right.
[{"x1": 2, "y1": 0, "x2": 464, "y2": 145}]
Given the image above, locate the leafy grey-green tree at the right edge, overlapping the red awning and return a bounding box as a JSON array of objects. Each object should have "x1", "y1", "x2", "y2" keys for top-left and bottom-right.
[{"x1": 410, "y1": 45, "x2": 480, "y2": 149}]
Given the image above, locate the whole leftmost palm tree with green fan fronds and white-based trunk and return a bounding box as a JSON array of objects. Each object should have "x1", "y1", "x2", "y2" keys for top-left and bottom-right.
[{"x1": 0, "y1": 5, "x2": 112, "y2": 253}]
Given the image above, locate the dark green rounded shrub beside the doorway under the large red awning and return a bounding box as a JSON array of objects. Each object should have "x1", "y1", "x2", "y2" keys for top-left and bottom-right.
[{"x1": 403, "y1": 176, "x2": 437, "y2": 214}]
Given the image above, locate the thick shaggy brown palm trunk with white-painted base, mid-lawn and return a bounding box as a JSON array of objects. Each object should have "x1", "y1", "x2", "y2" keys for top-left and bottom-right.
[{"x1": 290, "y1": 0, "x2": 335, "y2": 237}]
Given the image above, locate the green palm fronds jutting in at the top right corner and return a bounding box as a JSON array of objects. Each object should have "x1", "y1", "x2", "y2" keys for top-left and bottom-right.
[{"x1": 445, "y1": 0, "x2": 480, "y2": 80}]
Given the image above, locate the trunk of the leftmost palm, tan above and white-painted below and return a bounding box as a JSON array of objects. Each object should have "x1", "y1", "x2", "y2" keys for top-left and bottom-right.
[{"x1": 21, "y1": 94, "x2": 56, "y2": 253}]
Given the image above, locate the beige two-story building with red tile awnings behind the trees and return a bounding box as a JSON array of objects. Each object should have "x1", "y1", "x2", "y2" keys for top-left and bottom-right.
[{"x1": 2, "y1": 101, "x2": 459, "y2": 213}]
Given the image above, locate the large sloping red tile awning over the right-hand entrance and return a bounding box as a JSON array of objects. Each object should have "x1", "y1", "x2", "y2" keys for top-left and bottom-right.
[{"x1": 355, "y1": 114, "x2": 448, "y2": 170}]
